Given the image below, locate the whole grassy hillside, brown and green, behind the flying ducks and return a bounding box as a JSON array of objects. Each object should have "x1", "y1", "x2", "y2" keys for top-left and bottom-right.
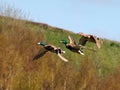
[{"x1": 0, "y1": 17, "x2": 120, "y2": 90}]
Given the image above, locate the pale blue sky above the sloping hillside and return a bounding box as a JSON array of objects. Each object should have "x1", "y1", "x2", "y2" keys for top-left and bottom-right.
[{"x1": 0, "y1": 0, "x2": 120, "y2": 41}]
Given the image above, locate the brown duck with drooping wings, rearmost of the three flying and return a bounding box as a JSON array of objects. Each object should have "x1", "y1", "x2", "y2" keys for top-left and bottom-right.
[{"x1": 77, "y1": 32, "x2": 101, "y2": 49}]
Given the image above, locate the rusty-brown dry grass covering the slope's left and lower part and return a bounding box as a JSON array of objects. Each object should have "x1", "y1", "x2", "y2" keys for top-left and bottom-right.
[{"x1": 0, "y1": 18, "x2": 120, "y2": 90}]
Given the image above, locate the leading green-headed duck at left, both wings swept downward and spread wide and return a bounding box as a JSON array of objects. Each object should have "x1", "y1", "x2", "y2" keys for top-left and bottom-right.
[{"x1": 33, "y1": 41, "x2": 68, "y2": 62}]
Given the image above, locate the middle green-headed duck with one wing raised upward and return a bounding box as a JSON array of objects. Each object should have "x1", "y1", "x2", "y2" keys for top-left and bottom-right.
[{"x1": 60, "y1": 35, "x2": 84, "y2": 55}]
